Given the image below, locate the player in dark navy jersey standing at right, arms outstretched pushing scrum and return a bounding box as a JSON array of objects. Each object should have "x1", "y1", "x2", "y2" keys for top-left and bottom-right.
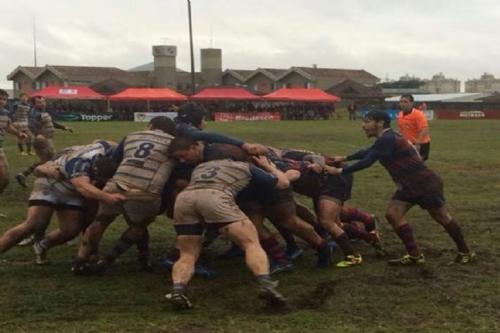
[{"x1": 326, "y1": 110, "x2": 475, "y2": 265}]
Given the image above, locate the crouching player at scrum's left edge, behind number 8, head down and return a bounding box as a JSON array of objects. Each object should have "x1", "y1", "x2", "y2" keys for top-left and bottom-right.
[{"x1": 0, "y1": 142, "x2": 125, "y2": 264}]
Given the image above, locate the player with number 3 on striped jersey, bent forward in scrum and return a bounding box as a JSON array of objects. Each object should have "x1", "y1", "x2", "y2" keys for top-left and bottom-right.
[{"x1": 166, "y1": 143, "x2": 289, "y2": 308}]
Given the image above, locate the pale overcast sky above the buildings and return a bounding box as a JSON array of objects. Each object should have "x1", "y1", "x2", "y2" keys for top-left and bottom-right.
[{"x1": 0, "y1": 0, "x2": 500, "y2": 88}]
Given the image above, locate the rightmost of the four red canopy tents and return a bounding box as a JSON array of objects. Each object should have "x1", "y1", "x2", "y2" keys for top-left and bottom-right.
[{"x1": 262, "y1": 88, "x2": 340, "y2": 103}]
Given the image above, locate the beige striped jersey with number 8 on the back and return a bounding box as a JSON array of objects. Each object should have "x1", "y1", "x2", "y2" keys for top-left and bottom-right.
[{"x1": 112, "y1": 130, "x2": 175, "y2": 195}]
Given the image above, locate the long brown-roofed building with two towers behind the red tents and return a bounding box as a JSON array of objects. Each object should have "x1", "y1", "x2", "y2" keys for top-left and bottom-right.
[{"x1": 7, "y1": 45, "x2": 380, "y2": 97}]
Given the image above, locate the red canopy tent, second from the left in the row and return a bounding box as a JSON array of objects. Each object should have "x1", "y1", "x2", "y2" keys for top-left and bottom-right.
[{"x1": 109, "y1": 88, "x2": 187, "y2": 102}]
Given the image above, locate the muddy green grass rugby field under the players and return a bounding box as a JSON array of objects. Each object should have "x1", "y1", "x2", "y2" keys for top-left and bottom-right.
[{"x1": 0, "y1": 120, "x2": 500, "y2": 333}]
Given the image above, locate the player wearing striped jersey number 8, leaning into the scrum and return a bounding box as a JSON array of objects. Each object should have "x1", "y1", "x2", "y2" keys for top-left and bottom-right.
[{"x1": 72, "y1": 117, "x2": 175, "y2": 274}]
